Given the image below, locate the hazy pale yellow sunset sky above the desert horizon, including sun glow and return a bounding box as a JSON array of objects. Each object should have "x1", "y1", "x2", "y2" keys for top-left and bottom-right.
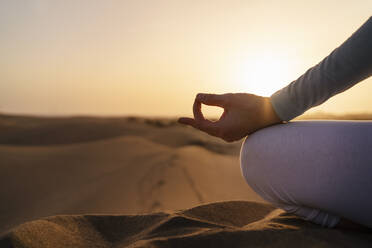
[{"x1": 0, "y1": 0, "x2": 372, "y2": 117}]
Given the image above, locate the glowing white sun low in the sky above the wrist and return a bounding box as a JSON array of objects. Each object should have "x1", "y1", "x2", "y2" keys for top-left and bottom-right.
[{"x1": 233, "y1": 53, "x2": 293, "y2": 96}]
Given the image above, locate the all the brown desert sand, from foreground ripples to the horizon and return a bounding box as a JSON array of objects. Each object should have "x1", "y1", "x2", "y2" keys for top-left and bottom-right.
[{"x1": 0, "y1": 115, "x2": 372, "y2": 247}]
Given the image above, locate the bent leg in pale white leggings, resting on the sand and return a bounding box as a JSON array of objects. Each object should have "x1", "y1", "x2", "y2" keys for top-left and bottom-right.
[{"x1": 240, "y1": 121, "x2": 372, "y2": 227}]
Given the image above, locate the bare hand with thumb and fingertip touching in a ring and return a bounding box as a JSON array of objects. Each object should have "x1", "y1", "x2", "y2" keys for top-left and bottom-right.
[{"x1": 178, "y1": 93, "x2": 282, "y2": 142}]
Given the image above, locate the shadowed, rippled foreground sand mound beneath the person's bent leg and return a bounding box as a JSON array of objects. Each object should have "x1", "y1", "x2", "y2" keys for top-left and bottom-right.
[{"x1": 0, "y1": 201, "x2": 372, "y2": 248}]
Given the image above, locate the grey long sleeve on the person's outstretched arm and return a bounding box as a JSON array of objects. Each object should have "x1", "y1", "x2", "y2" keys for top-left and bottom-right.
[{"x1": 270, "y1": 17, "x2": 372, "y2": 121}]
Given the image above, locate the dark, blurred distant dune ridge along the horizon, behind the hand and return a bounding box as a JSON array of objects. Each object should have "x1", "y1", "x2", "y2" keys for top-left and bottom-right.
[{"x1": 0, "y1": 115, "x2": 241, "y2": 155}]
